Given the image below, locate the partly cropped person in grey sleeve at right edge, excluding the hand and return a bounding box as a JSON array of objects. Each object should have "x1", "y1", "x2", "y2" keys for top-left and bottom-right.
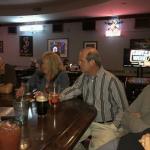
[{"x1": 100, "y1": 85, "x2": 150, "y2": 150}]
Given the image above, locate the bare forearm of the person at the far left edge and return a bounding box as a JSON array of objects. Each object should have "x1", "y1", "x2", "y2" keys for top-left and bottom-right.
[{"x1": 0, "y1": 83, "x2": 13, "y2": 94}]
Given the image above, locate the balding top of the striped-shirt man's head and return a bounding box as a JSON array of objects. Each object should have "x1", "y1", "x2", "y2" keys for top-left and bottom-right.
[{"x1": 80, "y1": 48, "x2": 101, "y2": 67}]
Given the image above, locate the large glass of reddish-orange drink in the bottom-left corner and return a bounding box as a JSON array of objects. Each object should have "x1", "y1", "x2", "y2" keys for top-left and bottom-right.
[{"x1": 0, "y1": 121, "x2": 21, "y2": 150}]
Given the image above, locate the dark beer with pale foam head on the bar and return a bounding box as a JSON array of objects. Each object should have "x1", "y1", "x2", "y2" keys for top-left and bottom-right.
[{"x1": 36, "y1": 95, "x2": 48, "y2": 116}]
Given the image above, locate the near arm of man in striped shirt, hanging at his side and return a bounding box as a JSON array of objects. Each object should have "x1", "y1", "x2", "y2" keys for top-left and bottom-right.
[{"x1": 111, "y1": 79, "x2": 128, "y2": 127}]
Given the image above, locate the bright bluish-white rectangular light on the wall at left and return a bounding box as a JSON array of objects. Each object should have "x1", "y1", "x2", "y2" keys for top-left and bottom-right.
[{"x1": 20, "y1": 25, "x2": 43, "y2": 32}]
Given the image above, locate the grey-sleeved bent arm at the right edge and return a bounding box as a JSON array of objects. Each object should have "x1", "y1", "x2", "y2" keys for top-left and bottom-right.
[{"x1": 122, "y1": 86, "x2": 150, "y2": 132}]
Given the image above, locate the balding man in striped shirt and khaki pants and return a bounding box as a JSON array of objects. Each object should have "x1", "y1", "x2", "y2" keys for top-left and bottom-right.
[{"x1": 61, "y1": 48, "x2": 128, "y2": 150}]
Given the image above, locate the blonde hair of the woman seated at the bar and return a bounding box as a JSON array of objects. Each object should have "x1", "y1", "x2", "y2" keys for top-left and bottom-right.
[{"x1": 42, "y1": 52, "x2": 64, "y2": 78}]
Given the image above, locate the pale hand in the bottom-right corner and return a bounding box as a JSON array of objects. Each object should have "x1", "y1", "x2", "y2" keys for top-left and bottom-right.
[{"x1": 139, "y1": 133, "x2": 150, "y2": 150}]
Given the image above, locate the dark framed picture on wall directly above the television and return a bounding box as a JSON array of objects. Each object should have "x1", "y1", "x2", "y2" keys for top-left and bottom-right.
[{"x1": 130, "y1": 39, "x2": 150, "y2": 49}]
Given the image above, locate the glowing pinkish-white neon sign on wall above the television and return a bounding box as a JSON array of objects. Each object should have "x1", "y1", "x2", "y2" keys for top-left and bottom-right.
[{"x1": 105, "y1": 18, "x2": 122, "y2": 37}]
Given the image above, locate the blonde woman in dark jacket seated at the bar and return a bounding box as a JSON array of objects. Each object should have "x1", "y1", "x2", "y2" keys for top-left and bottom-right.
[{"x1": 16, "y1": 52, "x2": 69, "y2": 97}]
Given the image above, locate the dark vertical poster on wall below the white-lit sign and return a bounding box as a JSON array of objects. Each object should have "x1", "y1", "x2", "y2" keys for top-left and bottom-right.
[{"x1": 19, "y1": 36, "x2": 33, "y2": 57}]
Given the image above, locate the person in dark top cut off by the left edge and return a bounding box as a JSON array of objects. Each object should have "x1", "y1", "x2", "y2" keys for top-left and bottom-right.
[{"x1": 0, "y1": 57, "x2": 16, "y2": 94}]
